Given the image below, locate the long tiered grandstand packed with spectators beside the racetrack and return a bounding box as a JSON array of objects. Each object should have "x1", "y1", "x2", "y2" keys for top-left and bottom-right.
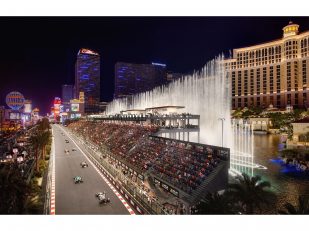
[{"x1": 68, "y1": 114, "x2": 229, "y2": 204}]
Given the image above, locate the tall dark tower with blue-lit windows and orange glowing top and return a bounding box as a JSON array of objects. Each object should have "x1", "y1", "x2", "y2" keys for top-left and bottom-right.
[{"x1": 74, "y1": 48, "x2": 100, "y2": 113}]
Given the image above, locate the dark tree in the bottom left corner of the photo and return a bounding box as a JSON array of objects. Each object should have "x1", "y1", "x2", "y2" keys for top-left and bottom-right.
[{"x1": 0, "y1": 164, "x2": 30, "y2": 214}]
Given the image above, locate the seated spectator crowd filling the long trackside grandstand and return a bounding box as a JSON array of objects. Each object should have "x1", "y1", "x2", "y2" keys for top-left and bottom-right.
[{"x1": 69, "y1": 120, "x2": 225, "y2": 193}]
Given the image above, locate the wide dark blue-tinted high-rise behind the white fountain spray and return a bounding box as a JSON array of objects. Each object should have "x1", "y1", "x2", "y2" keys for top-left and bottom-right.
[{"x1": 114, "y1": 62, "x2": 167, "y2": 98}]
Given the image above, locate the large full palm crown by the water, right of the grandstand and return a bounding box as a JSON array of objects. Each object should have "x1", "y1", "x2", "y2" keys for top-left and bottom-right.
[{"x1": 228, "y1": 173, "x2": 276, "y2": 214}]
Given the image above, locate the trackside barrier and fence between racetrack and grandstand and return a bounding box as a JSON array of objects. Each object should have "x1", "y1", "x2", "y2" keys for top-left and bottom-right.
[{"x1": 65, "y1": 132, "x2": 168, "y2": 214}]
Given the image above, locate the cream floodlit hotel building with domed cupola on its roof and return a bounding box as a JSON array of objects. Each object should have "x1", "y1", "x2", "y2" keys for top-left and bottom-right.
[{"x1": 225, "y1": 22, "x2": 309, "y2": 109}]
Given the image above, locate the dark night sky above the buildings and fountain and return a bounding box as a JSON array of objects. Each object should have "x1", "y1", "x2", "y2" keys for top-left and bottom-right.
[{"x1": 0, "y1": 17, "x2": 309, "y2": 114}]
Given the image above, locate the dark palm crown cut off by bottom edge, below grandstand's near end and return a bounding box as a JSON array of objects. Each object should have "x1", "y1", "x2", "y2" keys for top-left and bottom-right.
[{"x1": 192, "y1": 192, "x2": 236, "y2": 214}]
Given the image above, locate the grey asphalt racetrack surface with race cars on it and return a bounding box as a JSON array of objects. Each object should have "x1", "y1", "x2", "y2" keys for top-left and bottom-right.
[{"x1": 52, "y1": 125, "x2": 129, "y2": 214}]
